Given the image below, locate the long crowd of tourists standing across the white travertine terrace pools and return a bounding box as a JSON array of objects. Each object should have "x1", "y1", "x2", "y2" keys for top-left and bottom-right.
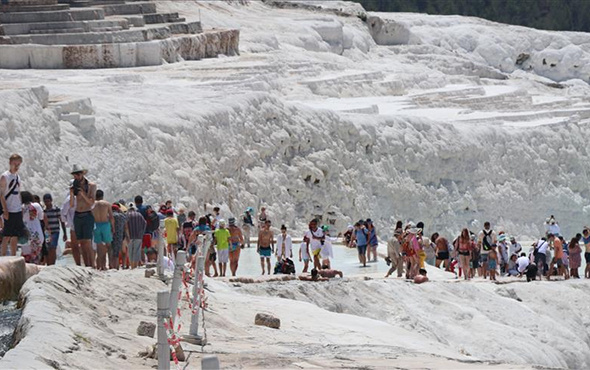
[{"x1": 0, "y1": 154, "x2": 590, "y2": 282}]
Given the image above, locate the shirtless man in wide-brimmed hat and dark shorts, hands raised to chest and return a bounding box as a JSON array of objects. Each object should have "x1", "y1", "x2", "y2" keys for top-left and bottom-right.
[{"x1": 70, "y1": 164, "x2": 96, "y2": 267}]
